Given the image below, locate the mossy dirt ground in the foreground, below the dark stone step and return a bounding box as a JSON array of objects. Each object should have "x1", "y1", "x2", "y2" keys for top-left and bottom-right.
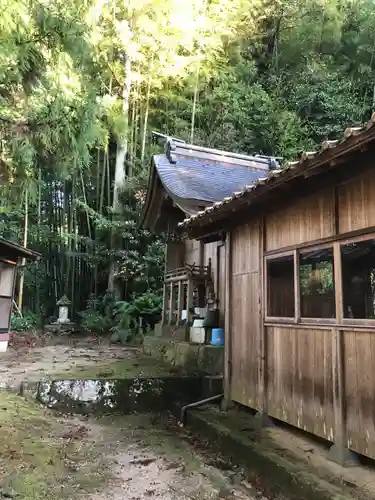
[{"x1": 0, "y1": 391, "x2": 276, "y2": 500}]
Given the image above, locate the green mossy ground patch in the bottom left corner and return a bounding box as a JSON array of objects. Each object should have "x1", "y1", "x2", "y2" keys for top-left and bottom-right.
[{"x1": 0, "y1": 392, "x2": 107, "y2": 500}]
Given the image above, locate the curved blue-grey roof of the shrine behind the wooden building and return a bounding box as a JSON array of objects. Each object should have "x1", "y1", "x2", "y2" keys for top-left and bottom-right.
[{"x1": 154, "y1": 154, "x2": 272, "y2": 203}]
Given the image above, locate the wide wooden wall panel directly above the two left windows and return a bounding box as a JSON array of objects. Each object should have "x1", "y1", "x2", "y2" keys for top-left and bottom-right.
[{"x1": 266, "y1": 188, "x2": 335, "y2": 251}]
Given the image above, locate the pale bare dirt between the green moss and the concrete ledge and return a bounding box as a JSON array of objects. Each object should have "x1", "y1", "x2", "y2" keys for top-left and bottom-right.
[{"x1": 85, "y1": 415, "x2": 267, "y2": 500}]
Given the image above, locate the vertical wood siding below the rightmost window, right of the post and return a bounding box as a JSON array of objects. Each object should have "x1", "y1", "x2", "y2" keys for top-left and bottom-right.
[{"x1": 343, "y1": 331, "x2": 375, "y2": 458}]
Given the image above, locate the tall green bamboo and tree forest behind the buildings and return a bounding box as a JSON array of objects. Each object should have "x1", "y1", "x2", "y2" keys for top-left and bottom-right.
[{"x1": 0, "y1": 0, "x2": 375, "y2": 324}]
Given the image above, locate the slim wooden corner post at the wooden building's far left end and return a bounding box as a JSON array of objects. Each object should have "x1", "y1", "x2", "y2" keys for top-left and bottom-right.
[{"x1": 223, "y1": 232, "x2": 232, "y2": 409}]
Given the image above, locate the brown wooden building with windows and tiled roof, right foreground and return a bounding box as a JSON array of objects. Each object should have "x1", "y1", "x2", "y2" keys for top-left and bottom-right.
[{"x1": 179, "y1": 116, "x2": 375, "y2": 462}]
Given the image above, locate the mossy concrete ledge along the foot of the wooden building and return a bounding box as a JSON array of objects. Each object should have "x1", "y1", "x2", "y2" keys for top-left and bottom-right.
[{"x1": 187, "y1": 408, "x2": 362, "y2": 500}]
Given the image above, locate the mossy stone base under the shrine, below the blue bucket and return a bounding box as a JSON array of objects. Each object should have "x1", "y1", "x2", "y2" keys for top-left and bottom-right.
[{"x1": 143, "y1": 337, "x2": 224, "y2": 375}]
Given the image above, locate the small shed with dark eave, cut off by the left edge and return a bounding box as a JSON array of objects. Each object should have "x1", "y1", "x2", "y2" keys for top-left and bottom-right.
[{"x1": 0, "y1": 238, "x2": 39, "y2": 352}]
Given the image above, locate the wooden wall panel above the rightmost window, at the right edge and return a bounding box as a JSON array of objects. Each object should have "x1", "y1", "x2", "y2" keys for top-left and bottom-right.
[{"x1": 338, "y1": 171, "x2": 375, "y2": 233}]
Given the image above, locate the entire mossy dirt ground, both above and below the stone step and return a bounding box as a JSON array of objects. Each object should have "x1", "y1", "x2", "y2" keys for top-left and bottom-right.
[{"x1": 0, "y1": 339, "x2": 278, "y2": 500}]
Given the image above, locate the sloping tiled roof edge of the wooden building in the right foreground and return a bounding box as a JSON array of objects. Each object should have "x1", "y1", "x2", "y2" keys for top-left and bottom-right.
[{"x1": 178, "y1": 113, "x2": 375, "y2": 228}]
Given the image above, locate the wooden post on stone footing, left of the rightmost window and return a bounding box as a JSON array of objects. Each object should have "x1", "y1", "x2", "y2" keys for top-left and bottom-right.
[{"x1": 330, "y1": 242, "x2": 358, "y2": 465}]
